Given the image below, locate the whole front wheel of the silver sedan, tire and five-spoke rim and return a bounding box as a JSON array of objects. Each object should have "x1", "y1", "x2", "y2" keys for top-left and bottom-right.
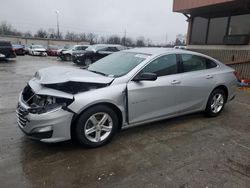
[{"x1": 75, "y1": 105, "x2": 118, "y2": 148}]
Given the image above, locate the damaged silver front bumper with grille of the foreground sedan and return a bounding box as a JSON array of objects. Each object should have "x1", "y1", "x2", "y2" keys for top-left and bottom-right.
[{"x1": 16, "y1": 84, "x2": 74, "y2": 143}]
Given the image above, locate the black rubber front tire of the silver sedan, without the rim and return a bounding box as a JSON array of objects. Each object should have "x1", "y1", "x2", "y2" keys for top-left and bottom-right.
[{"x1": 75, "y1": 105, "x2": 118, "y2": 148}]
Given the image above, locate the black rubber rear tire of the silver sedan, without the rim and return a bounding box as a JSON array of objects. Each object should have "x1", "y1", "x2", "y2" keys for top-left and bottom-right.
[{"x1": 205, "y1": 88, "x2": 226, "y2": 117}]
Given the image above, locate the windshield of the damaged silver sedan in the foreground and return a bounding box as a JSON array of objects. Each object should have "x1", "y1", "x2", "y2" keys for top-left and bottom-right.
[{"x1": 88, "y1": 52, "x2": 150, "y2": 77}]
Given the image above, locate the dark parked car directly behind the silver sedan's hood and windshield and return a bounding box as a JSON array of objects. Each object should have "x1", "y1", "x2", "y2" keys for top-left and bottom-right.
[{"x1": 72, "y1": 44, "x2": 125, "y2": 66}]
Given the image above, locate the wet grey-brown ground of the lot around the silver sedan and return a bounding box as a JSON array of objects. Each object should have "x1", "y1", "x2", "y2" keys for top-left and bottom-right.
[{"x1": 0, "y1": 56, "x2": 250, "y2": 188}]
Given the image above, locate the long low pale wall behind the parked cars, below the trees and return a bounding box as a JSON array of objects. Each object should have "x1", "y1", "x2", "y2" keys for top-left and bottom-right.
[{"x1": 0, "y1": 36, "x2": 89, "y2": 47}]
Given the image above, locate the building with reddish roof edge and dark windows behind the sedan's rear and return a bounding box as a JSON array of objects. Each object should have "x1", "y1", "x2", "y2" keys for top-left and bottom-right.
[{"x1": 173, "y1": 0, "x2": 250, "y2": 78}]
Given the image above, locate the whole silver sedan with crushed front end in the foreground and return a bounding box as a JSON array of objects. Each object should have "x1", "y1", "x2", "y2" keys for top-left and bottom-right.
[{"x1": 17, "y1": 48, "x2": 236, "y2": 147}]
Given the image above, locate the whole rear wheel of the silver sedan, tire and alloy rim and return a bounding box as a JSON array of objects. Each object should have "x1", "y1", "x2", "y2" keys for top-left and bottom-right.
[{"x1": 205, "y1": 89, "x2": 226, "y2": 117}]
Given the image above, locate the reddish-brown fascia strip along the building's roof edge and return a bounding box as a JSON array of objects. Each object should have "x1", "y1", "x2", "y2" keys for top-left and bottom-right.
[{"x1": 173, "y1": 0, "x2": 234, "y2": 12}]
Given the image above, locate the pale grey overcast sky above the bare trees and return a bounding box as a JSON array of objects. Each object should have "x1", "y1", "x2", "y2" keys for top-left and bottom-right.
[{"x1": 0, "y1": 0, "x2": 187, "y2": 43}]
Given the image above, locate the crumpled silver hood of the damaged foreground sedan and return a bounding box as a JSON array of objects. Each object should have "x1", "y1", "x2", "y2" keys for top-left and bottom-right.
[{"x1": 33, "y1": 67, "x2": 114, "y2": 84}]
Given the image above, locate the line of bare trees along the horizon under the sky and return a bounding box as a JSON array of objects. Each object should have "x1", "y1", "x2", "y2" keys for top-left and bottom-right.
[{"x1": 0, "y1": 22, "x2": 185, "y2": 47}]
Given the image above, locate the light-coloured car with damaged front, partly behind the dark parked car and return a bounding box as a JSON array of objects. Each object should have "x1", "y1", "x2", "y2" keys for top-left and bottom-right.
[{"x1": 58, "y1": 45, "x2": 89, "y2": 61}]
